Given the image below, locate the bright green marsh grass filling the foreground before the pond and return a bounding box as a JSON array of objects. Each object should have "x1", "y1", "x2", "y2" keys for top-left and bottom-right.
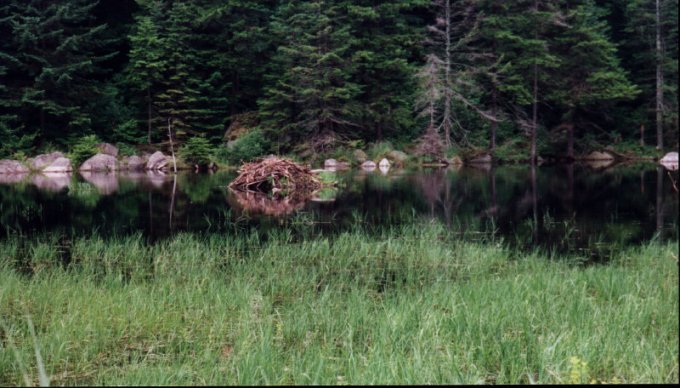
[{"x1": 0, "y1": 225, "x2": 678, "y2": 385}]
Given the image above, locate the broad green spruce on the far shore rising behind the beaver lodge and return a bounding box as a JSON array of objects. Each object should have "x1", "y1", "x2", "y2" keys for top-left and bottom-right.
[{"x1": 260, "y1": 0, "x2": 360, "y2": 150}]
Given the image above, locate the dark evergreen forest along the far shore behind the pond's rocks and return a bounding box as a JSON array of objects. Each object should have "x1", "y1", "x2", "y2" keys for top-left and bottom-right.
[{"x1": 0, "y1": 0, "x2": 678, "y2": 164}]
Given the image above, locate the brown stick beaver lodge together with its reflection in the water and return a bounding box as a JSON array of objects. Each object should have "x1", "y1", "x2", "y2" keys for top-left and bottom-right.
[{"x1": 229, "y1": 156, "x2": 322, "y2": 216}]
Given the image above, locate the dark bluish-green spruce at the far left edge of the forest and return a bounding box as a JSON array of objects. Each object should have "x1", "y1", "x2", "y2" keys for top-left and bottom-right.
[{"x1": 0, "y1": 0, "x2": 115, "y2": 146}]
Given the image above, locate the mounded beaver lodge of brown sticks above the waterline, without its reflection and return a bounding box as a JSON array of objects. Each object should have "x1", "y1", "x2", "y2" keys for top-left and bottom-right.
[{"x1": 229, "y1": 156, "x2": 323, "y2": 198}]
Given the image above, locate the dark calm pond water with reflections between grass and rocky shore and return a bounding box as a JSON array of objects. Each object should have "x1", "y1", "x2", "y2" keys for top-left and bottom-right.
[{"x1": 0, "y1": 164, "x2": 678, "y2": 259}]
